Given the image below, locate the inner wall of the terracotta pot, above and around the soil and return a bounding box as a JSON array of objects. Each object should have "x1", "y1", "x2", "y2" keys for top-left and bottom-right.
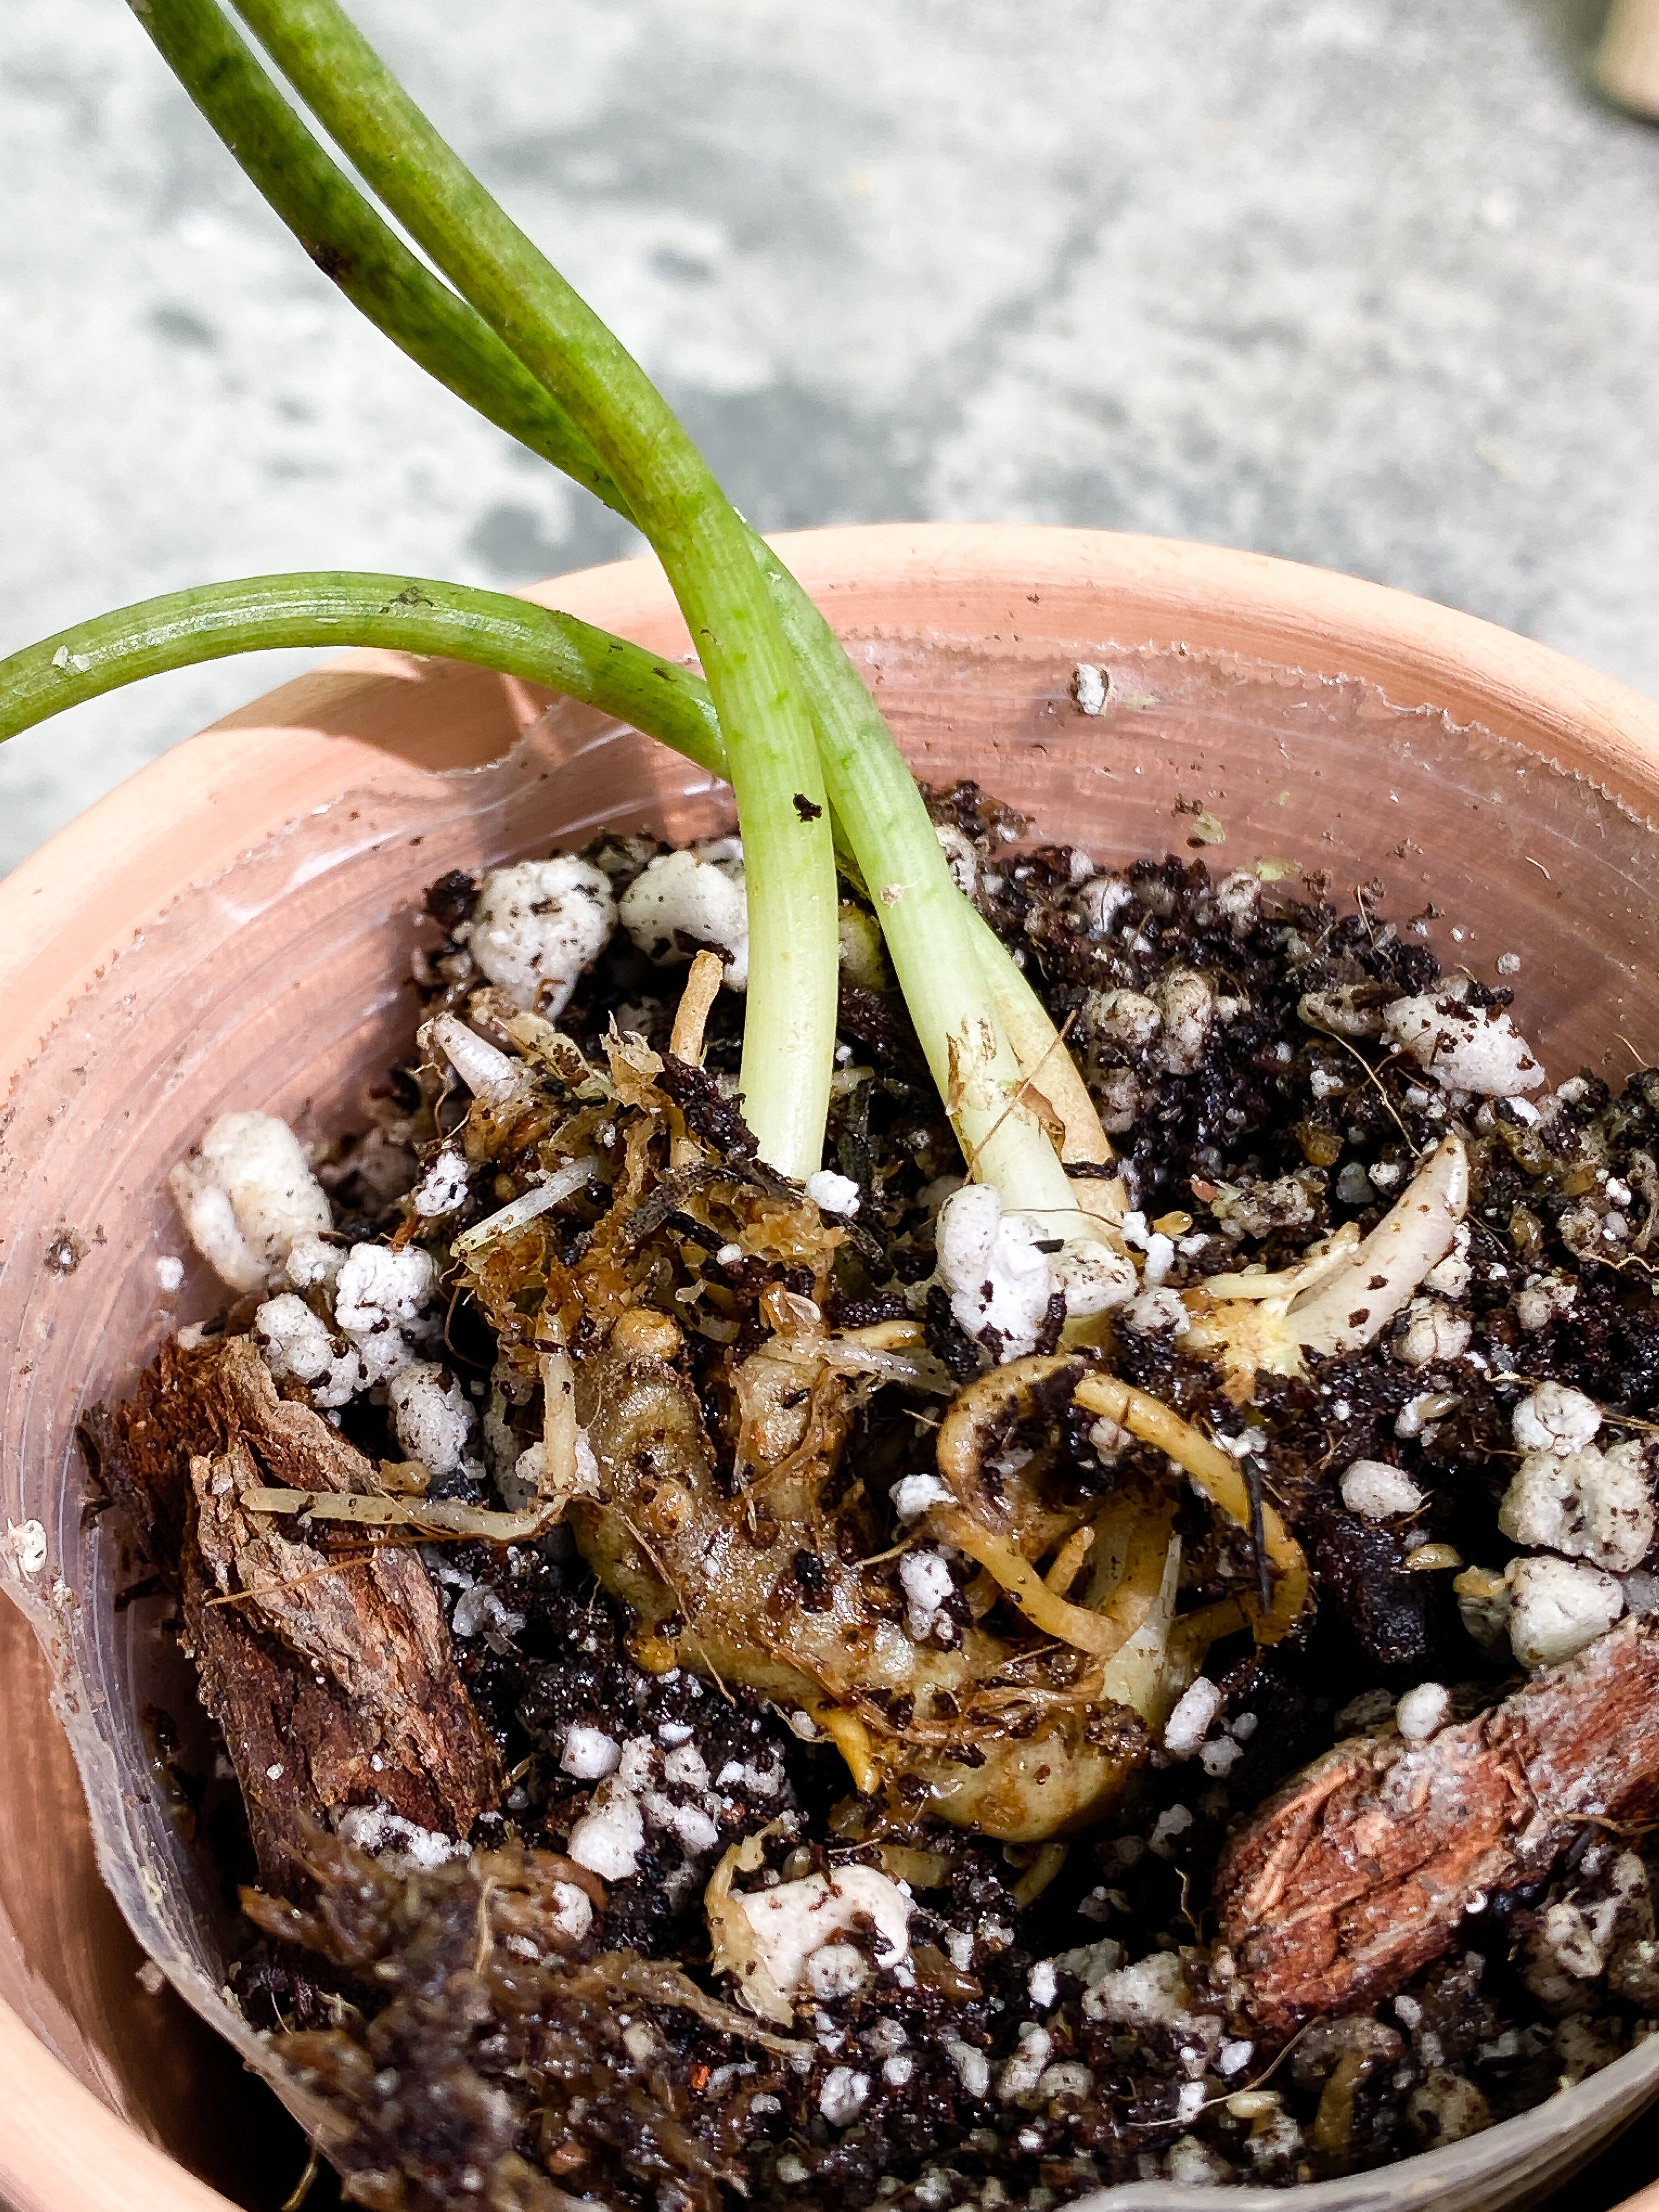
[{"x1": 0, "y1": 606, "x2": 1659, "y2": 2205}]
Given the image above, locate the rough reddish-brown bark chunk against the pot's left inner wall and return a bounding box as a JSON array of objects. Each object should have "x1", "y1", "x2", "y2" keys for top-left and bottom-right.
[{"x1": 182, "y1": 1338, "x2": 504, "y2": 1887}]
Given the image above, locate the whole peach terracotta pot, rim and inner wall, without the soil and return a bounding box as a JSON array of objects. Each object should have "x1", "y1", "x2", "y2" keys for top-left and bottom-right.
[{"x1": 0, "y1": 527, "x2": 1659, "y2": 2212}]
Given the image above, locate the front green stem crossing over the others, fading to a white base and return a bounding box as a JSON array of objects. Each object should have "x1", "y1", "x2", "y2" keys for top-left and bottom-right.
[{"x1": 228, "y1": 0, "x2": 838, "y2": 1177}]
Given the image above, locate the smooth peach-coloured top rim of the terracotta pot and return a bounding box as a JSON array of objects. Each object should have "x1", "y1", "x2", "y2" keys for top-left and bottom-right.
[{"x1": 0, "y1": 522, "x2": 1659, "y2": 2212}]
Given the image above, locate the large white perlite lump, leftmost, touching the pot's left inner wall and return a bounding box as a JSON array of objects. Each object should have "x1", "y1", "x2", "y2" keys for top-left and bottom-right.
[{"x1": 168, "y1": 1113, "x2": 334, "y2": 1294}]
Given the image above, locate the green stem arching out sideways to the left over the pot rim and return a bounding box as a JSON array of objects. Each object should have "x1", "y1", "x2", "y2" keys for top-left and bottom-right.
[{"x1": 0, "y1": 573, "x2": 725, "y2": 776}]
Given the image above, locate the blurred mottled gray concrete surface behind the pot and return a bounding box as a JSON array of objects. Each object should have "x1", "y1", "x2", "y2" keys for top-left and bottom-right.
[{"x1": 0, "y1": 0, "x2": 1659, "y2": 865}]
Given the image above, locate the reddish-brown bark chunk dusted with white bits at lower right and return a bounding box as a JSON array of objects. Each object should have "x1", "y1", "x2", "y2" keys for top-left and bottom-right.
[{"x1": 1215, "y1": 1621, "x2": 1659, "y2": 2035}]
